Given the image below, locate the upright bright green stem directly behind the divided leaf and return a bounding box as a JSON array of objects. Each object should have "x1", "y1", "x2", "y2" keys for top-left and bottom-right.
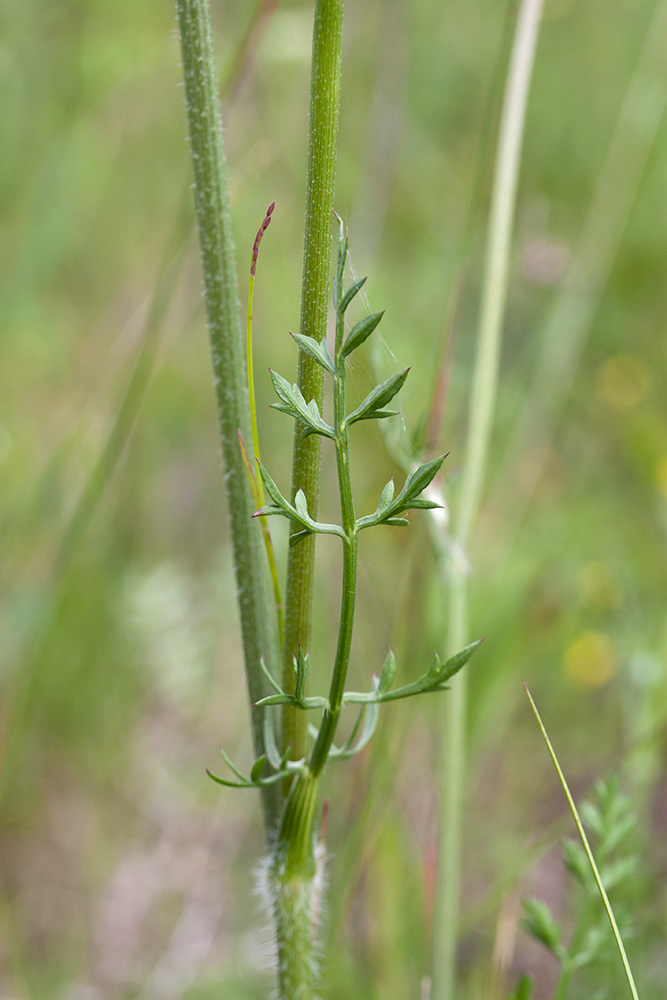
[{"x1": 282, "y1": 0, "x2": 343, "y2": 772}]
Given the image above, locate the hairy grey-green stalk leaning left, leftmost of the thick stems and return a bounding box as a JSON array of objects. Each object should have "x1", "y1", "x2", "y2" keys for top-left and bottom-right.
[{"x1": 177, "y1": 0, "x2": 280, "y2": 830}]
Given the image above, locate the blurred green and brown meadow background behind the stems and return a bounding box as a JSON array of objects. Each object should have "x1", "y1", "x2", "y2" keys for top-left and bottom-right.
[{"x1": 0, "y1": 0, "x2": 667, "y2": 1000}]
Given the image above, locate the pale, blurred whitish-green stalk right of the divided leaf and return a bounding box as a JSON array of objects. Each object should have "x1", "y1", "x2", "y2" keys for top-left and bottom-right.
[{"x1": 431, "y1": 0, "x2": 542, "y2": 1000}]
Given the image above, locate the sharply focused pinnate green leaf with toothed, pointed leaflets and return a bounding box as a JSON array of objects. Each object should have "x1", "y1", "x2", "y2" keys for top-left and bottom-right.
[{"x1": 211, "y1": 219, "x2": 481, "y2": 788}]
